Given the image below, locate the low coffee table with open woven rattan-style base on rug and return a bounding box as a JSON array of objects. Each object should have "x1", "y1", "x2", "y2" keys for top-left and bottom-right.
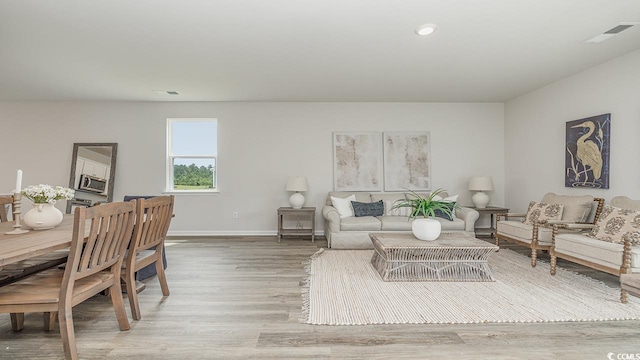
[{"x1": 369, "y1": 232, "x2": 499, "y2": 281}]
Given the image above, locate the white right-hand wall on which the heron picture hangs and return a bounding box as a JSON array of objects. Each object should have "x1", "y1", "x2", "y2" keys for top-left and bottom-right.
[{"x1": 505, "y1": 50, "x2": 640, "y2": 211}]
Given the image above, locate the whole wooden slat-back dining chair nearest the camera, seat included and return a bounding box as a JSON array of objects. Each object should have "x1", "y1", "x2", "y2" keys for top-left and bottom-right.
[{"x1": 0, "y1": 201, "x2": 136, "y2": 359}]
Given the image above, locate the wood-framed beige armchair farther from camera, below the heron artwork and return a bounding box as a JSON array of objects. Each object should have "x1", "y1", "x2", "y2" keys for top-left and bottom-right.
[{"x1": 496, "y1": 193, "x2": 604, "y2": 267}]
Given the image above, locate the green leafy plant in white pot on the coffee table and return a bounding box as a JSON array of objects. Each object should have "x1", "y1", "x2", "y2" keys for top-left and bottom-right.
[{"x1": 393, "y1": 189, "x2": 457, "y2": 240}]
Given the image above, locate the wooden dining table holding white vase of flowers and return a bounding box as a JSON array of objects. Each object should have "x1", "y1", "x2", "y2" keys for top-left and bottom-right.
[{"x1": 0, "y1": 214, "x2": 73, "y2": 269}]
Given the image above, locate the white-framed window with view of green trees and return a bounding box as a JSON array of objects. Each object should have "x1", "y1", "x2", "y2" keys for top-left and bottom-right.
[{"x1": 167, "y1": 119, "x2": 218, "y2": 192}]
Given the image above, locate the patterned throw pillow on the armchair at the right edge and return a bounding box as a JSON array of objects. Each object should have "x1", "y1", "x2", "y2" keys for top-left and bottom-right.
[{"x1": 588, "y1": 205, "x2": 640, "y2": 245}]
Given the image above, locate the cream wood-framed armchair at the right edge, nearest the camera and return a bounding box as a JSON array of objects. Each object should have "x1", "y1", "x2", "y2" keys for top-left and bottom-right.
[{"x1": 550, "y1": 196, "x2": 640, "y2": 282}]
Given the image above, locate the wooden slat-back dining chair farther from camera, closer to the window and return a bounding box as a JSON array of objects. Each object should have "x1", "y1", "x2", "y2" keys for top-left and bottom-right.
[{"x1": 122, "y1": 195, "x2": 174, "y2": 320}]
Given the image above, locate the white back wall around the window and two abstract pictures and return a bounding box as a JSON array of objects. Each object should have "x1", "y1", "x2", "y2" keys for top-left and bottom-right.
[{"x1": 0, "y1": 102, "x2": 504, "y2": 235}]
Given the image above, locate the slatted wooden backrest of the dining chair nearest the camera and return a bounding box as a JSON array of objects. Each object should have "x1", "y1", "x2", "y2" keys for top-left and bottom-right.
[{"x1": 65, "y1": 202, "x2": 135, "y2": 282}]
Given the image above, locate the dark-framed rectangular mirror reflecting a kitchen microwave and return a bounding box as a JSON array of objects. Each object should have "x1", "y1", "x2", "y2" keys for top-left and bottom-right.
[{"x1": 67, "y1": 143, "x2": 118, "y2": 214}]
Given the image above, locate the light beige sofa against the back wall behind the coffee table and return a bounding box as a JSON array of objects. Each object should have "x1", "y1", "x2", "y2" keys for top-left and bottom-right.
[{"x1": 322, "y1": 191, "x2": 480, "y2": 249}]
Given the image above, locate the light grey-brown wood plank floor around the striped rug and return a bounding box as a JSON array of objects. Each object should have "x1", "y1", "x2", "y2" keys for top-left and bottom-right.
[{"x1": 0, "y1": 237, "x2": 640, "y2": 360}]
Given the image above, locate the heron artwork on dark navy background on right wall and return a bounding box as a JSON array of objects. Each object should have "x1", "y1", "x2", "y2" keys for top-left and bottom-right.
[{"x1": 565, "y1": 114, "x2": 611, "y2": 189}]
